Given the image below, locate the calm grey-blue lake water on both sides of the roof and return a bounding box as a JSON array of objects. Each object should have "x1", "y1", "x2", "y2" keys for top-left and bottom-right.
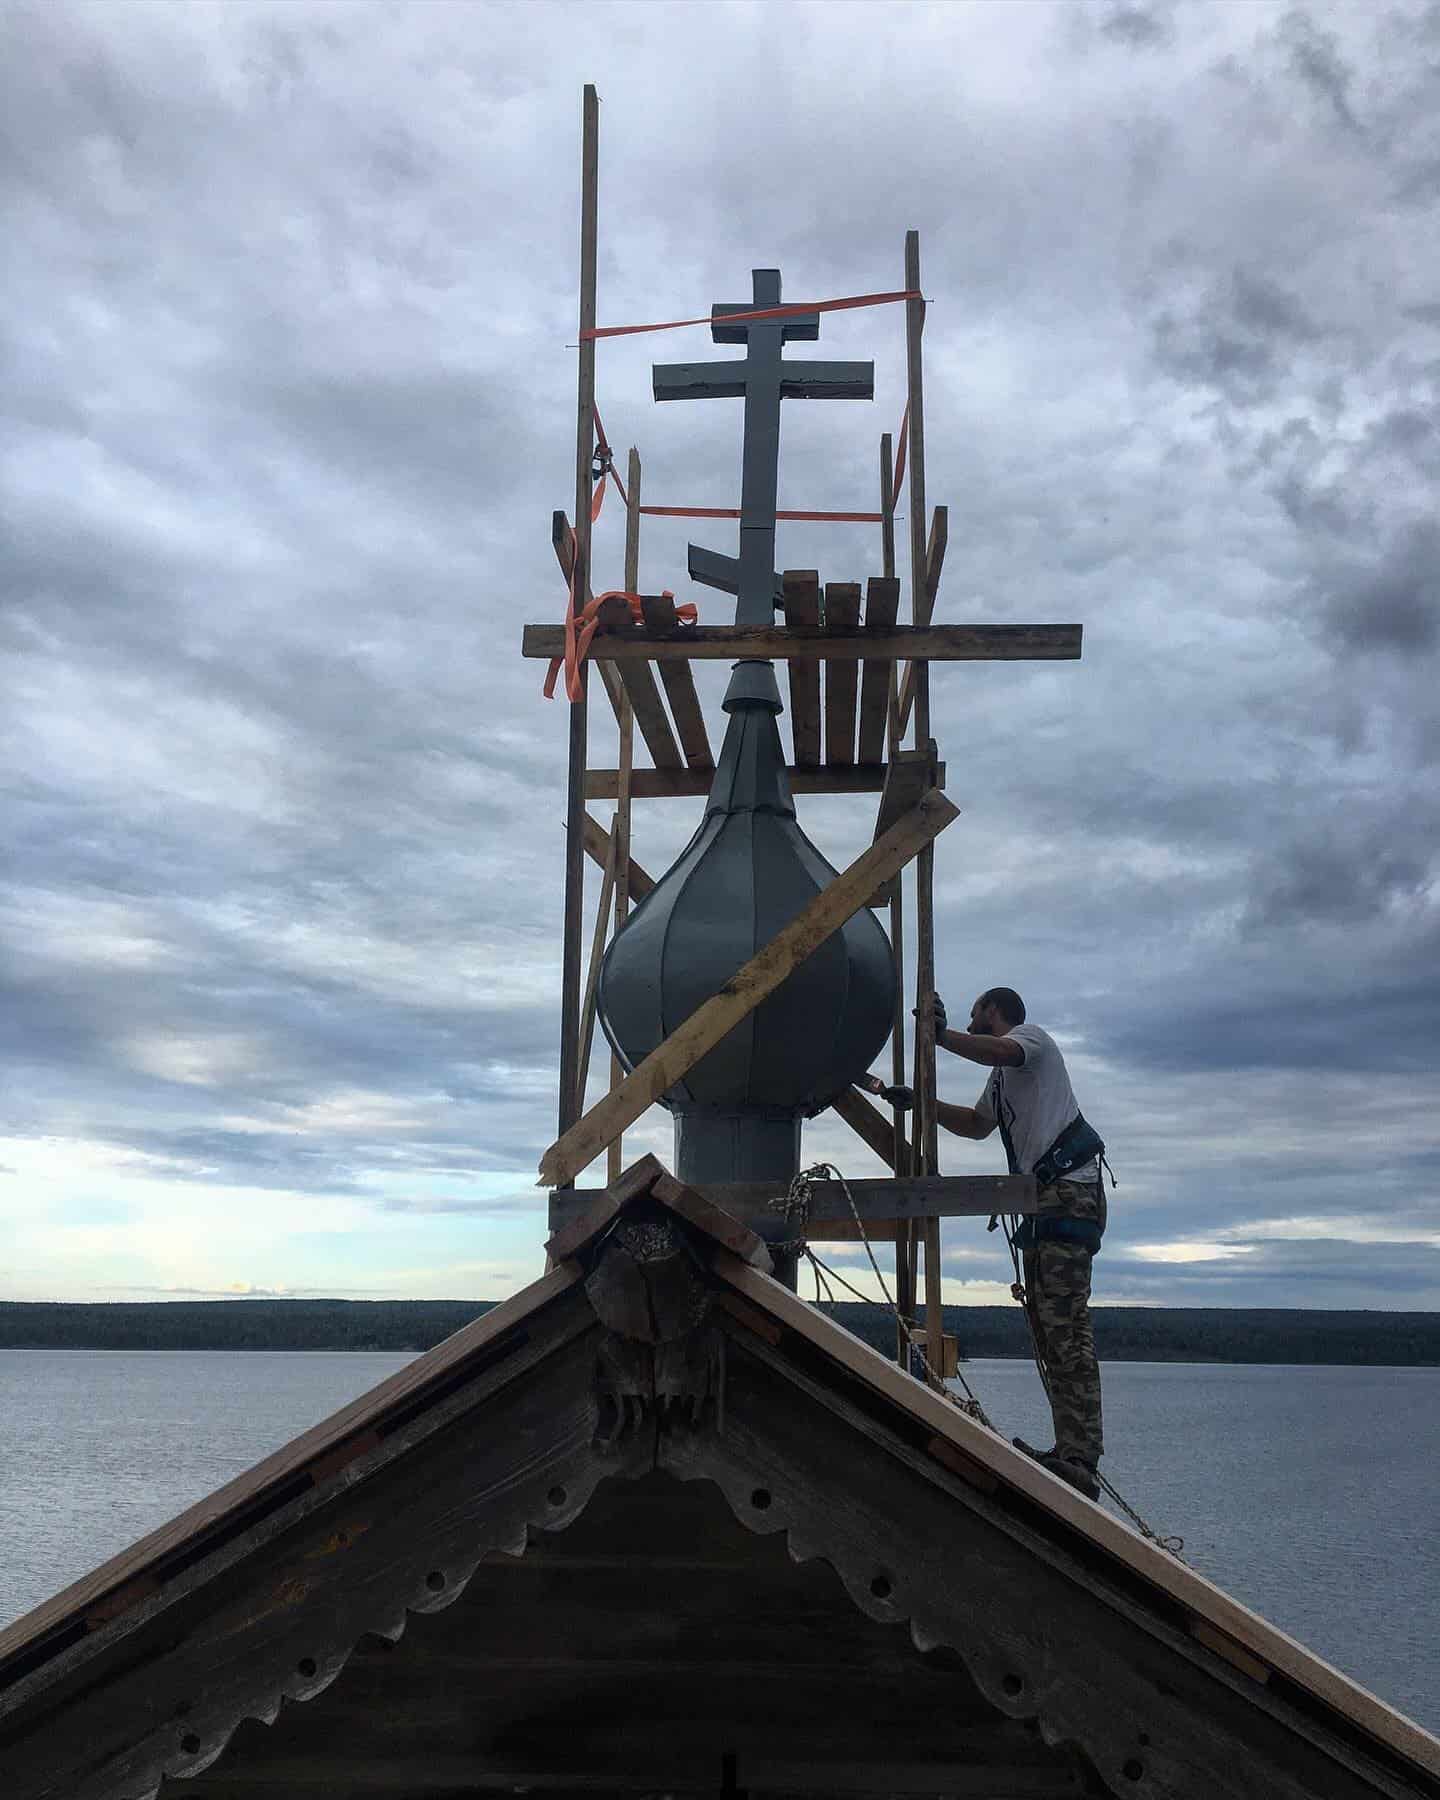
[{"x1": 0, "y1": 1350, "x2": 1440, "y2": 1732}]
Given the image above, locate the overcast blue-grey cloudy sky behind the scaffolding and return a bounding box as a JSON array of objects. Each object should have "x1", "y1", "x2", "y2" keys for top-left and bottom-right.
[{"x1": 0, "y1": 0, "x2": 1440, "y2": 1307}]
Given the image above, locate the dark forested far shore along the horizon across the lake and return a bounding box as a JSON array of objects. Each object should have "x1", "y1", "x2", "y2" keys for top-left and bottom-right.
[{"x1": 0, "y1": 1300, "x2": 1440, "y2": 1366}]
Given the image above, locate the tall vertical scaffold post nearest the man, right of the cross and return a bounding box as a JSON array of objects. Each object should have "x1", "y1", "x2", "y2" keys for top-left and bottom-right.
[{"x1": 905, "y1": 230, "x2": 945, "y2": 1372}]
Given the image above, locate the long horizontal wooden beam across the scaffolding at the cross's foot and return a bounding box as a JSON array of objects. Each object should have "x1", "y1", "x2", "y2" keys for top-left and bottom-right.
[{"x1": 520, "y1": 625, "x2": 1084, "y2": 666}]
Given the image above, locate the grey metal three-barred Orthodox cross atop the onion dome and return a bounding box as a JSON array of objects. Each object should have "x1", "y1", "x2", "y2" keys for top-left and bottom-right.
[{"x1": 653, "y1": 268, "x2": 875, "y2": 625}]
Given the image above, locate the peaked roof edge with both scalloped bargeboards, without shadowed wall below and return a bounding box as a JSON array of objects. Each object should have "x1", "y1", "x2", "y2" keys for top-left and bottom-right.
[{"x1": 0, "y1": 1157, "x2": 1440, "y2": 1800}]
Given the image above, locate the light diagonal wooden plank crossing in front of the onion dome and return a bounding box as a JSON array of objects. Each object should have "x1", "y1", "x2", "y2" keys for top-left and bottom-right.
[{"x1": 540, "y1": 788, "x2": 959, "y2": 1188}]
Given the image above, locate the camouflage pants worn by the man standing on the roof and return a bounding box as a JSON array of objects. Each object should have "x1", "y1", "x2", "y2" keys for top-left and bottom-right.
[{"x1": 1024, "y1": 1181, "x2": 1105, "y2": 1463}]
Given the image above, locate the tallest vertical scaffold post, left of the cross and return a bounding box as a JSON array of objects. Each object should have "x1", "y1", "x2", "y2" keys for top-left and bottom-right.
[{"x1": 560, "y1": 83, "x2": 599, "y2": 1186}]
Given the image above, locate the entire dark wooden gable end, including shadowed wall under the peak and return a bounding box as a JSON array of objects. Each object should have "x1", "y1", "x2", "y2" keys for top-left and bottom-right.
[{"x1": 0, "y1": 1157, "x2": 1440, "y2": 1800}]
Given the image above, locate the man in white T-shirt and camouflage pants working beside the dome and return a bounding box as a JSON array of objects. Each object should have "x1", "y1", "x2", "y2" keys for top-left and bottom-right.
[{"x1": 918, "y1": 988, "x2": 1105, "y2": 1499}]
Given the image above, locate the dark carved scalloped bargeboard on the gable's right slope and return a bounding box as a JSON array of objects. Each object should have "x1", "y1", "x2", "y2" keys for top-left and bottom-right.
[{"x1": 659, "y1": 1309, "x2": 1440, "y2": 1800}]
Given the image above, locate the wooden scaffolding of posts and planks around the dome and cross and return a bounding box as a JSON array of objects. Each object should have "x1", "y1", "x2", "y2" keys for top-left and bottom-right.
[{"x1": 524, "y1": 86, "x2": 1082, "y2": 1379}]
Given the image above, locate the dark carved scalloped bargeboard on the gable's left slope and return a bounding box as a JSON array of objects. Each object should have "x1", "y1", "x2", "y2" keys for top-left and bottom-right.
[{"x1": 0, "y1": 1294, "x2": 640, "y2": 1800}]
